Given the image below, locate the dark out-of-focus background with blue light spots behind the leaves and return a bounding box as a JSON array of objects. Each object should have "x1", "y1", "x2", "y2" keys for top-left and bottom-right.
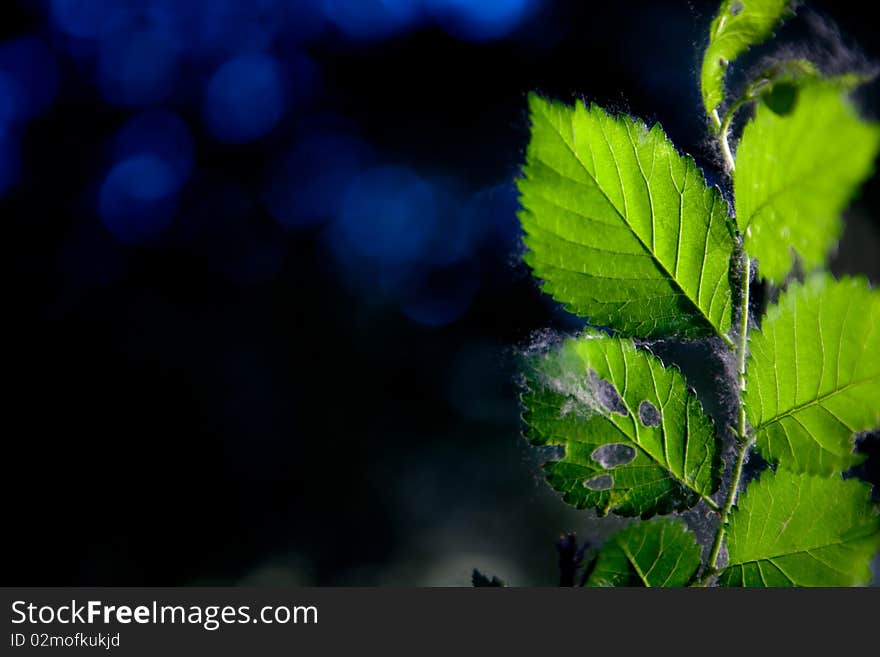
[{"x1": 6, "y1": 0, "x2": 880, "y2": 585}]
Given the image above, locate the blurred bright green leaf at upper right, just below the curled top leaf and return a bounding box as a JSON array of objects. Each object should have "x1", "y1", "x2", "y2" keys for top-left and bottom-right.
[{"x1": 733, "y1": 79, "x2": 880, "y2": 284}]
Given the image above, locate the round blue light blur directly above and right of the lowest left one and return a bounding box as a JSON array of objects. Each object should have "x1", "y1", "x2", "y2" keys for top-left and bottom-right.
[{"x1": 203, "y1": 53, "x2": 285, "y2": 143}]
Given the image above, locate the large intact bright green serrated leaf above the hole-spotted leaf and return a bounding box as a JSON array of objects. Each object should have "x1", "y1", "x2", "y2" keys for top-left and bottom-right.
[{"x1": 519, "y1": 94, "x2": 733, "y2": 337}]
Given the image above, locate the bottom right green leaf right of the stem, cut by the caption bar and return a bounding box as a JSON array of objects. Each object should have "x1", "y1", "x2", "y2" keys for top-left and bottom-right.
[{"x1": 718, "y1": 470, "x2": 880, "y2": 586}]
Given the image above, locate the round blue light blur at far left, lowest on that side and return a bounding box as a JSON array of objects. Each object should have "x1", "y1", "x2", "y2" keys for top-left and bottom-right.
[{"x1": 99, "y1": 154, "x2": 177, "y2": 244}]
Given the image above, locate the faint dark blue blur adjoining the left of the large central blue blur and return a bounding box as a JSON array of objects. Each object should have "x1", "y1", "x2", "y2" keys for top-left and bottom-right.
[{"x1": 263, "y1": 131, "x2": 371, "y2": 230}]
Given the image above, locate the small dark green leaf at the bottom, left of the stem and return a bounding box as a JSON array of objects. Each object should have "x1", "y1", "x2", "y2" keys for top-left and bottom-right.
[{"x1": 587, "y1": 518, "x2": 701, "y2": 587}]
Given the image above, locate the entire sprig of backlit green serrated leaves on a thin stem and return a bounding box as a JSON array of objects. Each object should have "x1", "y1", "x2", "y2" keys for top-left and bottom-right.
[{"x1": 518, "y1": 0, "x2": 880, "y2": 586}]
